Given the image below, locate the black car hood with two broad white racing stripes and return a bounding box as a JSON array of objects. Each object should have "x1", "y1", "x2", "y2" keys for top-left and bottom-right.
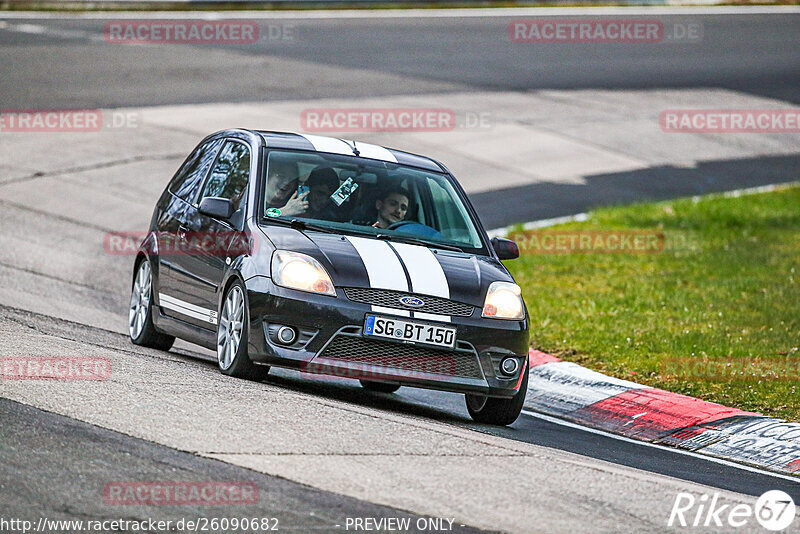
[{"x1": 265, "y1": 226, "x2": 514, "y2": 307}]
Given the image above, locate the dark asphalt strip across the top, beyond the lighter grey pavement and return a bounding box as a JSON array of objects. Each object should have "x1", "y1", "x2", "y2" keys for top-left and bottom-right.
[{"x1": 0, "y1": 8, "x2": 800, "y2": 108}]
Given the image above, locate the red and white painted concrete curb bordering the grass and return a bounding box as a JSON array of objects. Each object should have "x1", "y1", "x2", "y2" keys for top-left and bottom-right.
[{"x1": 525, "y1": 349, "x2": 800, "y2": 478}]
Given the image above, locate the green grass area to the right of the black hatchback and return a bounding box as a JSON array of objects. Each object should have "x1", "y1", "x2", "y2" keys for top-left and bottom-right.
[{"x1": 507, "y1": 187, "x2": 800, "y2": 421}]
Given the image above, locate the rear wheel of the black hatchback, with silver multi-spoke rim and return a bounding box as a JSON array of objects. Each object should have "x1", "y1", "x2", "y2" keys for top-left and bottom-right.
[{"x1": 128, "y1": 258, "x2": 175, "y2": 350}]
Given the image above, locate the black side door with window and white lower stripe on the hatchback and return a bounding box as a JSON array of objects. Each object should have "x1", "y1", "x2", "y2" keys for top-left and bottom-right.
[{"x1": 168, "y1": 139, "x2": 251, "y2": 330}]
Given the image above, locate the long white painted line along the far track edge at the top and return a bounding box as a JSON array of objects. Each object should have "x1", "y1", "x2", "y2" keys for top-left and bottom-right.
[{"x1": 0, "y1": 6, "x2": 800, "y2": 20}]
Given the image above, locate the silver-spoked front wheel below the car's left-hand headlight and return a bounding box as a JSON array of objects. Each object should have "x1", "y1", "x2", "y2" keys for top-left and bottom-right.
[{"x1": 217, "y1": 280, "x2": 269, "y2": 380}]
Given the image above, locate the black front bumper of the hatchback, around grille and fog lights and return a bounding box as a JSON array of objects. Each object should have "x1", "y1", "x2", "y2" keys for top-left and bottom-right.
[{"x1": 245, "y1": 276, "x2": 528, "y2": 398}]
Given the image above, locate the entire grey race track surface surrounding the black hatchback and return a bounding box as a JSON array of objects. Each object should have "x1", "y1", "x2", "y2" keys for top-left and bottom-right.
[{"x1": 0, "y1": 8, "x2": 800, "y2": 532}]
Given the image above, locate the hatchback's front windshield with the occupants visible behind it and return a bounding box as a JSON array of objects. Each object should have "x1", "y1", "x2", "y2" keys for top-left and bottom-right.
[{"x1": 261, "y1": 150, "x2": 483, "y2": 252}]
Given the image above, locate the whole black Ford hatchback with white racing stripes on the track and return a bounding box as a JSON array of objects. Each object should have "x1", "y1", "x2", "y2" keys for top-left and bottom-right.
[{"x1": 129, "y1": 130, "x2": 528, "y2": 425}]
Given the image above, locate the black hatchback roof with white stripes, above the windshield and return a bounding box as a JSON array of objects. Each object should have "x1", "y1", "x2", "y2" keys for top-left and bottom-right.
[{"x1": 244, "y1": 130, "x2": 446, "y2": 172}]
